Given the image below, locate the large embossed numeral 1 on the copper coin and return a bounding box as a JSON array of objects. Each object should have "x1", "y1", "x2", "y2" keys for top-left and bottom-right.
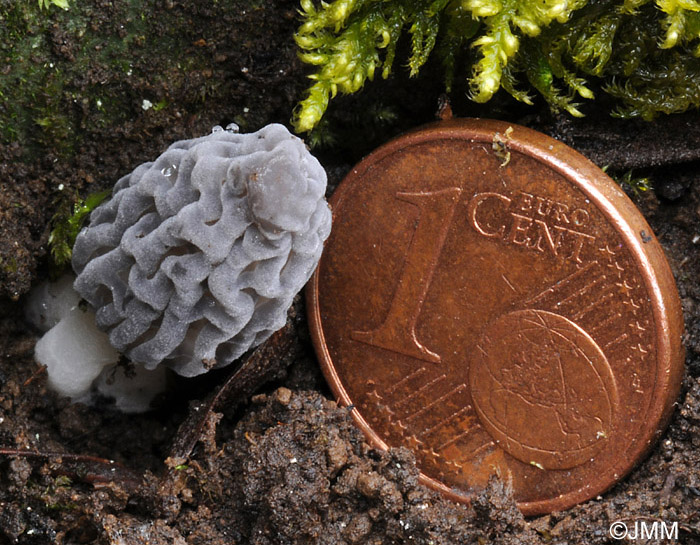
[{"x1": 350, "y1": 187, "x2": 462, "y2": 363}]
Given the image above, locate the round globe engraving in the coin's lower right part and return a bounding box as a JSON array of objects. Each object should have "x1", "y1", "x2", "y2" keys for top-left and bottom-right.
[{"x1": 469, "y1": 310, "x2": 618, "y2": 469}]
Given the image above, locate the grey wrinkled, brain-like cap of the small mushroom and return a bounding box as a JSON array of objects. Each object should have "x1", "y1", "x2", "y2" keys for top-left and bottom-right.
[{"x1": 30, "y1": 125, "x2": 331, "y2": 410}]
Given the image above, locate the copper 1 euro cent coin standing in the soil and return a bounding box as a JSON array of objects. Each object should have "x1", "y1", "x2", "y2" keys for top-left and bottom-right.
[{"x1": 307, "y1": 120, "x2": 683, "y2": 515}]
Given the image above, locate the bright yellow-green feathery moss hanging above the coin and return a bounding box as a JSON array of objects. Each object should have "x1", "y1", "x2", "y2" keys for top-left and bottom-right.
[{"x1": 293, "y1": 0, "x2": 700, "y2": 132}]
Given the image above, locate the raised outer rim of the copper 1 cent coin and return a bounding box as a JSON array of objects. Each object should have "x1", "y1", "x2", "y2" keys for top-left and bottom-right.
[{"x1": 306, "y1": 118, "x2": 685, "y2": 515}]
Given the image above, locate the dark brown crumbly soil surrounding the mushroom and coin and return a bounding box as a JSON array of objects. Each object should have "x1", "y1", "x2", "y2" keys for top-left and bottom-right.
[{"x1": 0, "y1": 0, "x2": 700, "y2": 545}]
